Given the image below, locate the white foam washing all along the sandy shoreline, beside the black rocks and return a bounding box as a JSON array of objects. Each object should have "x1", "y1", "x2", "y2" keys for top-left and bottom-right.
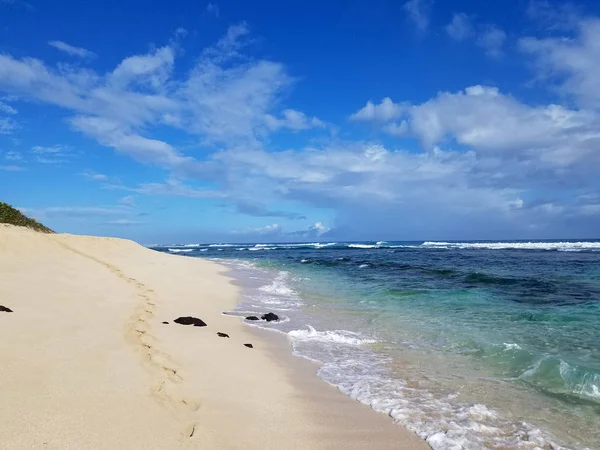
[{"x1": 227, "y1": 260, "x2": 576, "y2": 450}]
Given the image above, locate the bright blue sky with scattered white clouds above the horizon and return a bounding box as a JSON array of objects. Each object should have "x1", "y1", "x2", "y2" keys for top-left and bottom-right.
[{"x1": 0, "y1": 0, "x2": 600, "y2": 244}]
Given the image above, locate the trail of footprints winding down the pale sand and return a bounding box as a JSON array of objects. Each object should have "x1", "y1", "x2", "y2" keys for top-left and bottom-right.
[{"x1": 56, "y1": 241, "x2": 200, "y2": 438}]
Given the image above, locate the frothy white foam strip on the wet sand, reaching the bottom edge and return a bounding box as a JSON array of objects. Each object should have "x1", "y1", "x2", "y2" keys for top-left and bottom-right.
[{"x1": 314, "y1": 356, "x2": 564, "y2": 450}]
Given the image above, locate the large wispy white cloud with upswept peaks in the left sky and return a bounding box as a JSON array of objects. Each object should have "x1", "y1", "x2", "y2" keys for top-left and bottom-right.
[{"x1": 0, "y1": 23, "x2": 324, "y2": 167}]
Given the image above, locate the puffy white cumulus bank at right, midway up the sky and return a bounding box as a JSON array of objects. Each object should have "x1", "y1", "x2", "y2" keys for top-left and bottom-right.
[{"x1": 352, "y1": 85, "x2": 600, "y2": 166}]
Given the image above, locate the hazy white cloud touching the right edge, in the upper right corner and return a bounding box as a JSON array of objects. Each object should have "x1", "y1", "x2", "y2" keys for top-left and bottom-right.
[{"x1": 519, "y1": 18, "x2": 600, "y2": 109}]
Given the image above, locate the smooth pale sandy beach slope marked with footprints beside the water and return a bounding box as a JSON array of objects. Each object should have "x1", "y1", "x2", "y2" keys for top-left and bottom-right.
[{"x1": 0, "y1": 225, "x2": 428, "y2": 450}]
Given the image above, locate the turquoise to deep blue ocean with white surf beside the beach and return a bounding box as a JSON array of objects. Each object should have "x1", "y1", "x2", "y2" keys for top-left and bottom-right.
[{"x1": 152, "y1": 240, "x2": 600, "y2": 450}]
